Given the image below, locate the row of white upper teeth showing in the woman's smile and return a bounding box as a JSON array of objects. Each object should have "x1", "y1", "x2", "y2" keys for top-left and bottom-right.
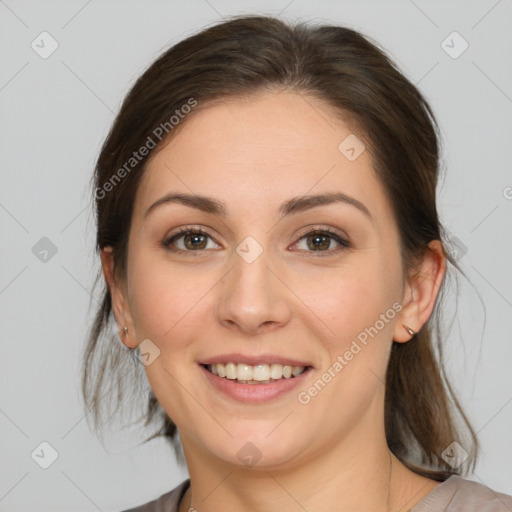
[{"x1": 208, "y1": 363, "x2": 305, "y2": 383}]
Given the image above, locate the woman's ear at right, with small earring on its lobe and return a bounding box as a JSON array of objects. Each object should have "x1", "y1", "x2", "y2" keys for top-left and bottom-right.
[{"x1": 393, "y1": 240, "x2": 446, "y2": 343}]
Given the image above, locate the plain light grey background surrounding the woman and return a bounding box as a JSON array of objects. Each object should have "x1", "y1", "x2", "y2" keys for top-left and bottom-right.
[{"x1": 0, "y1": 0, "x2": 512, "y2": 512}]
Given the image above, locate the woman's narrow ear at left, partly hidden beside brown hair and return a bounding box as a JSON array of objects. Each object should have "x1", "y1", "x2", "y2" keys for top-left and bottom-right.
[{"x1": 100, "y1": 247, "x2": 137, "y2": 348}]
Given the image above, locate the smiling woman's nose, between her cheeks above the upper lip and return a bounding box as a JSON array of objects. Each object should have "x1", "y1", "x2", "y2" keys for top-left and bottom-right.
[{"x1": 217, "y1": 244, "x2": 291, "y2": 335}]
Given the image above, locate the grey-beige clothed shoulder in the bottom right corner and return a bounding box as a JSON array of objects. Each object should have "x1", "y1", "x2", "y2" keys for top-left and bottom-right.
[{"x1": 410, "y1": 475, "x2": 512, "y2": 512}]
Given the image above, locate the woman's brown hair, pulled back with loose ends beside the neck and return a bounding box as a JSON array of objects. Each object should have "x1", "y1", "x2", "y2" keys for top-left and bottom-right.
[{"x1": 82, "y1": 16, "x2": 478, "y2": 481}]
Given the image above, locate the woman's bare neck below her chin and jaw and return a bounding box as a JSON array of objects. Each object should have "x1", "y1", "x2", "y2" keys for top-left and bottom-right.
[{"x1": 180, "y1": 428, "x2": 403, "y2": 512}]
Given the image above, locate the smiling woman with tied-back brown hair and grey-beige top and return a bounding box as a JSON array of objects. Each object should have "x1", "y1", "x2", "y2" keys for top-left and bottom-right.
[{"x1": 83, "y1": 16, "x2": 512, "y2": 512}]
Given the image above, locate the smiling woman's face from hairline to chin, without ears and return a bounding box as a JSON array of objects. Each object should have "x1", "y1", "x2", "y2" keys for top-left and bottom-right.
[{"x1": 115, "y1": 92, "x2": 408, "y2": 467}]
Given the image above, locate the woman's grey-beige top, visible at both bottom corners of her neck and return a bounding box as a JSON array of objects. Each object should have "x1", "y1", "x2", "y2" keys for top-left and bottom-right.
[{"x1": 124, "y1": 475, "x2": 512, "y2": 512}]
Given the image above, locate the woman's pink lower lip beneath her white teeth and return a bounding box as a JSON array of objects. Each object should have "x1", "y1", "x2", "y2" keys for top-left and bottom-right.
[{"x1": 199, "y1": 365, "x2": 312, "y2": 404}]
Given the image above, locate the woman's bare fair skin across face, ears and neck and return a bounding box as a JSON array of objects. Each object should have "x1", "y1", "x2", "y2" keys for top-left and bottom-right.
[{"x1": 102, "y1": 92, "x2": 446, "y2": 512}]
